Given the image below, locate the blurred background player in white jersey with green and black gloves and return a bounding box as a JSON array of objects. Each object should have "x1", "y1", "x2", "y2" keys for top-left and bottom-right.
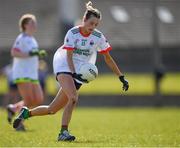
[{"x1": 7, "y1": 14, "x2": 46, "y2": 130}]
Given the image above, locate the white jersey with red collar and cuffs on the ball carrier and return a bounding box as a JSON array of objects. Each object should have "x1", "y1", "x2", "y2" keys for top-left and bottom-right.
[{"x1": 53, "y1": 26, "x2": 112, "y2": 74}]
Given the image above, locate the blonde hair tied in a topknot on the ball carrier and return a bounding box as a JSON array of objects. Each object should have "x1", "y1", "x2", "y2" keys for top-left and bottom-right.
[{"x1": 84, "y1": 1, "x2": 101, "y2": 20}]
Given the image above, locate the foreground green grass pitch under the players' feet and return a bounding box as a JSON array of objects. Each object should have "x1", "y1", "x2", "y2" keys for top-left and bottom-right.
[{"x1": 0, "y1": 108, "x2": 180, "y2": 147}]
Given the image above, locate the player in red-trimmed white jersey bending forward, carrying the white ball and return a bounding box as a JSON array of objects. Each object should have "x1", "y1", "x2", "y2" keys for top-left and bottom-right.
[{"x1": 13, "y1": 2, "x2": 129, "y2": 141}]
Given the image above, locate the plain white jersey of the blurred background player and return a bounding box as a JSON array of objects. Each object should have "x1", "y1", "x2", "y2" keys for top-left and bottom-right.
[{"x1": 13, "y1": 33, "x2": 39, "y2": 80}]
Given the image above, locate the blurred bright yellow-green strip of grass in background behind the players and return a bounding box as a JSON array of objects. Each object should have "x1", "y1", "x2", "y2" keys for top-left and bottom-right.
[{"x1": 0, "y1": 73, "x2": 180, "y2": 95}]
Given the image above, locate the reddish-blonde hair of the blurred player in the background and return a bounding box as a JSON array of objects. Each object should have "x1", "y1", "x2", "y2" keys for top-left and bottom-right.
[{"x1": 19, "y1": 14, "x2": 36, "y2": 32}]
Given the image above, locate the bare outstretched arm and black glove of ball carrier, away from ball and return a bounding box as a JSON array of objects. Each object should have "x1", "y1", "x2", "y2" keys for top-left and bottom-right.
[{"x1": 103, "y1": 52, "x2": 129, "y2": 91}]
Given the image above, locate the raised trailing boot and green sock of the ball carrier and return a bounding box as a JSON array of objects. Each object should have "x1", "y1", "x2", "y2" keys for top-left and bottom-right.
[{"x1": 13, "y1": 107, "x2": 29, "y2": 128}]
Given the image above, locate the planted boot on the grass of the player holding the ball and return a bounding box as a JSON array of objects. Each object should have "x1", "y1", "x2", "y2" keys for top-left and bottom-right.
[{"x1": 58, "y1": 130, "x2": 76, "y2": 141}]
